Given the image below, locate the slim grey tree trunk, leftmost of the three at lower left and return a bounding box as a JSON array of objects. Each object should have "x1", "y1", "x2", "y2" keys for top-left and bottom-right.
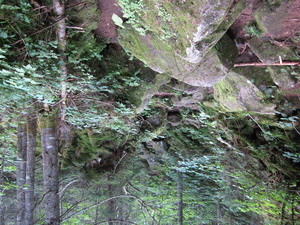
[{"x1": 16, "y1": 124, "x2": 27, "y2": 225}]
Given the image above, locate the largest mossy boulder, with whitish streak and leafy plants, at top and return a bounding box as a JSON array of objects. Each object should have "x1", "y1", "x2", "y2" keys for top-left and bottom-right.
[{"x1": 119, "y1": 0, "x2": 245, "y2": 87}]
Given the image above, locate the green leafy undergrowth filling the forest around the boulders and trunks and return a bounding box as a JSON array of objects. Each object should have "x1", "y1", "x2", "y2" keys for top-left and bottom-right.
[{"x1": 0, "y1": 0, "x2": 300, "y2": 224}]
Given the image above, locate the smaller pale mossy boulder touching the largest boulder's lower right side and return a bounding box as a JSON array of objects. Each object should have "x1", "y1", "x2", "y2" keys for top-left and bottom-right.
[{"x1": 214, "y1": 72, "x2": 275, "y2": 114}]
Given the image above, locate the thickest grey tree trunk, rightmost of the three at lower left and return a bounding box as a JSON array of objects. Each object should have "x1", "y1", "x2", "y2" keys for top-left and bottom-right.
[{"x1": 40, "y1": 117, "x2": 60, "y2": 225}]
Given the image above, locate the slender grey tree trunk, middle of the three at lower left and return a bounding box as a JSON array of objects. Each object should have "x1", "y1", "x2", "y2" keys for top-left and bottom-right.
[{"x1": 23, "y1": 114, "x2": 37, "y2": 225}]
